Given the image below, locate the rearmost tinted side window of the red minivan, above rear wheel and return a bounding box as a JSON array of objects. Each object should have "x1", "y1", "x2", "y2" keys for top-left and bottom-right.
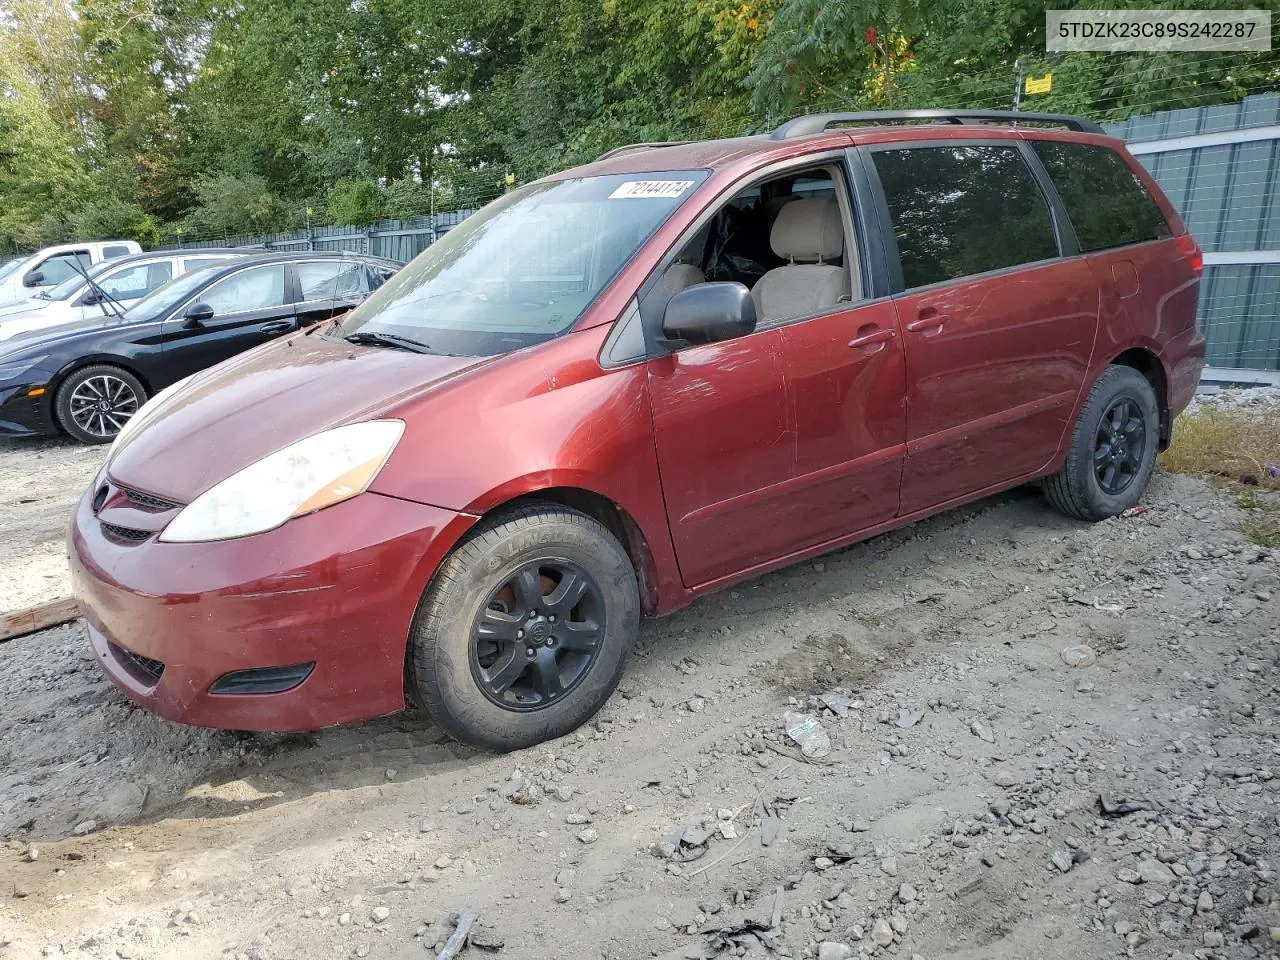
[{"x1": 1032, "y1": 140, "x2": 1169, "y2": 253}]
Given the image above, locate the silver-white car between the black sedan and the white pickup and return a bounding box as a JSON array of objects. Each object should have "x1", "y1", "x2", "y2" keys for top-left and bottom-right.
[{"x1": 0, "y1": 248, "x2": 243, "y2": 340}]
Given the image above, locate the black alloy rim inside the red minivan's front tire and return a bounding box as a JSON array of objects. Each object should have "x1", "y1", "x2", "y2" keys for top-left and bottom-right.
[{"x1": 470, "y1": 559, "x2": 605, "y2": 710}]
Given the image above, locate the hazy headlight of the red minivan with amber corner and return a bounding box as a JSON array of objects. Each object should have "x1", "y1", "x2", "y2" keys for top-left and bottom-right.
[{"x1": 160, "y1": 420, "x2": 404, "y2": 543}]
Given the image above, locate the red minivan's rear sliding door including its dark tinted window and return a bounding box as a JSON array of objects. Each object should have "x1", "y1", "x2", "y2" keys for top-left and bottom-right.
[{"x1": 870, "y1": 141, "x2": 1098, "y2": 515}]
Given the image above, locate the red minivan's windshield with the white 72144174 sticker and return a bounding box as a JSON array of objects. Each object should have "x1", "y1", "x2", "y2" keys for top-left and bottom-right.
[{"x1": 332, "y1": 170, "x2": 707, "y2": 356}]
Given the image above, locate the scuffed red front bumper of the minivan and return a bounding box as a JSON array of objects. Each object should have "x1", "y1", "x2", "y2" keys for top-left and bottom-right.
[{"x1": 68, "y1": 490, "x2": 474, "y2": 731}]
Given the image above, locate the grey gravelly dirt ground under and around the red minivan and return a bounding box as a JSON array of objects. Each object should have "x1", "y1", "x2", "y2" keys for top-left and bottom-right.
[{"x1": 0, "y1": 417, "x2": 1280, "y2": 960}]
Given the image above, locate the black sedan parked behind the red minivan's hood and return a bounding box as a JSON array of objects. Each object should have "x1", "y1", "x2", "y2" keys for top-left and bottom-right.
[{"x1": 0, "y1": 252, "x2": 401, "y2": 443}]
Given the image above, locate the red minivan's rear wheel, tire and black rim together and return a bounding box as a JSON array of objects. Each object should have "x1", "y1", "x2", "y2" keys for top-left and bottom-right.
[{"x1": 1044, "y1": 366, "x2": 1160, "y2": 521}]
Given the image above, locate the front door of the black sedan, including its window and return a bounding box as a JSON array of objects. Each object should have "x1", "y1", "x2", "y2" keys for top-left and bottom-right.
[{"x1": 164, "y1": 264, "x2": 297, "y2": 380}]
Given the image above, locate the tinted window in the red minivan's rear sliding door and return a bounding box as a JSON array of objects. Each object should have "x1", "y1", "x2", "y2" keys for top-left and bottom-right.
[{"x1": 872, "y1": 146, "x2": 1059, "y2": 289}]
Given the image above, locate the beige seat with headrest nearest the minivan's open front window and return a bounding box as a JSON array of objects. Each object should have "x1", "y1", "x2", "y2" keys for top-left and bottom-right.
[{"x1": 751, "y1": 197, "x2": 849, "y2": 324}]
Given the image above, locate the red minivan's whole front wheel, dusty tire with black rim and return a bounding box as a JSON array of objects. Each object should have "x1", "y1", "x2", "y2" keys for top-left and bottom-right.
[{"x1": 408, "y1": 504, "x2": 640, "y2": 751}]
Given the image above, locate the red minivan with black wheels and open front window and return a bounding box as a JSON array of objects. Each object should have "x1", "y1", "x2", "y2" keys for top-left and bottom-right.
[{"x1": 69, "y1": 110, "x2": 1204, "y2": 750}]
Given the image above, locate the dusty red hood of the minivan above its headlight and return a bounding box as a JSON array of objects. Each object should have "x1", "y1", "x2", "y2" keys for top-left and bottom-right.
[{"x1": 108, "y1": 335, "x2": 493, "y2": 503}]
